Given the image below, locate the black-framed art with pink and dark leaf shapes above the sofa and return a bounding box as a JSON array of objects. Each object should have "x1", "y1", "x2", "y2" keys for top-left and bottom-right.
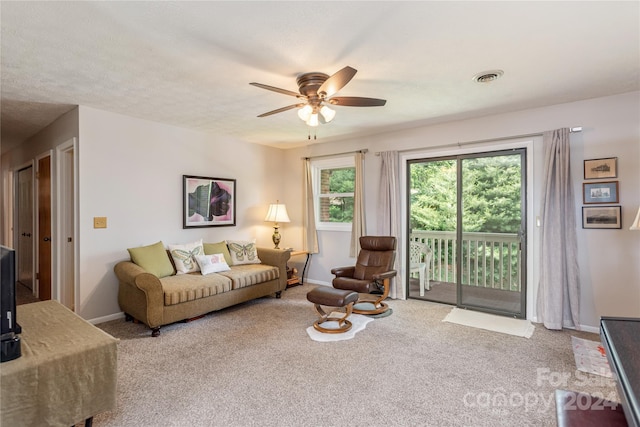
[{"x1": 182, "y1": 175, "x2": 236, "y2": 228}]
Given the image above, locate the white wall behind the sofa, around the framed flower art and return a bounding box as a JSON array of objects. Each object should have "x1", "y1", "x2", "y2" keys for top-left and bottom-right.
[{"x1": 78, "y1": 106, "x2": 282, "y2": 319}]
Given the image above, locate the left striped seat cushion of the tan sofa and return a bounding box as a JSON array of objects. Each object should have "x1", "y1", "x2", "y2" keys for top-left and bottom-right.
[{"x1": 160, "y1": 273, "x2": 231, "y2": 305}]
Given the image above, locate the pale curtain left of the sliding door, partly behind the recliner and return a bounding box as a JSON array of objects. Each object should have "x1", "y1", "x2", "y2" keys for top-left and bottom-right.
[{"x1": 378, "y1": 151, "x2": 407, "y2": 299}]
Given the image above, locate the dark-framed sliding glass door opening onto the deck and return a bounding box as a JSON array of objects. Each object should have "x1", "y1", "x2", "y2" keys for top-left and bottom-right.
[{"x1": 406, "y1": 149, "x2": 526, "y2": 318}]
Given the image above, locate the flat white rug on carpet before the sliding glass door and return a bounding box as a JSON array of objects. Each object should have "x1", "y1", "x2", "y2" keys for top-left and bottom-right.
[{"x1": 442, "y1": 307, "x2": 535, "y2": 338}]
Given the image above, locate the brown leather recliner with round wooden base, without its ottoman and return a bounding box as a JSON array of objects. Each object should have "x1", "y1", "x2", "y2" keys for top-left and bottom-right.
[{"x1": 331, "y1": 236, "x2": 396, "y2": 314}]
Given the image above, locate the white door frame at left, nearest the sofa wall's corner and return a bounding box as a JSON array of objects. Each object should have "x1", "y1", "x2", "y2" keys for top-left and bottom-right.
[{"x1": 52, "y1": 137, "x2": 80, "y2": 313}]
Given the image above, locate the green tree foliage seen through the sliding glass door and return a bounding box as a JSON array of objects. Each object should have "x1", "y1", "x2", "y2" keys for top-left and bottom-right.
[{"x1": 409, "y1": 154, "x2": 522, "y2": 290}]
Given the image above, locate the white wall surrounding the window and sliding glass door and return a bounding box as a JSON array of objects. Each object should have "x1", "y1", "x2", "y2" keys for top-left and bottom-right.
[{"x1": 285, "y1": 92, "x2": 640, "y2": 328}]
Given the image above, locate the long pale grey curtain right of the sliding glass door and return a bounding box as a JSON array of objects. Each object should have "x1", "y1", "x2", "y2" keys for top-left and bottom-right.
[{"x1": 537, "y1": 128, "x2": 580, "y2": 330}]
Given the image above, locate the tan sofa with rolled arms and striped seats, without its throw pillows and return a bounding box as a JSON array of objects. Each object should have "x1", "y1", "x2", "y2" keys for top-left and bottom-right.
[{"x1": 114, "y1": 248, "x2": 290, "y2": 337}]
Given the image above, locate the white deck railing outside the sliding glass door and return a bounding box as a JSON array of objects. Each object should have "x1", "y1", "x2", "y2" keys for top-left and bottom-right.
[{"x1": 410, "y1": 230, "x2": 522, "y2": 292}]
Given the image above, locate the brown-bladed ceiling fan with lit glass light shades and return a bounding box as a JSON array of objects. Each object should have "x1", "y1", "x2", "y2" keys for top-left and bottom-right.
[{"x1": 249, "y1": 66, "x2": 387, "y2": 126}]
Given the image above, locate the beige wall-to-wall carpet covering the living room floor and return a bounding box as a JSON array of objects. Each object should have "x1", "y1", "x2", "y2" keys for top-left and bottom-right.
[{"x1": 94, "y1": 285, "x2": 615, "y2": 427}]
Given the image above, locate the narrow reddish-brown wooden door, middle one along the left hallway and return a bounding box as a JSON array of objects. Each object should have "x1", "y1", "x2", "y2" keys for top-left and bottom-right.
[{"x1": 37, "y1": 156, "x2": 51, "y2": 300}]
